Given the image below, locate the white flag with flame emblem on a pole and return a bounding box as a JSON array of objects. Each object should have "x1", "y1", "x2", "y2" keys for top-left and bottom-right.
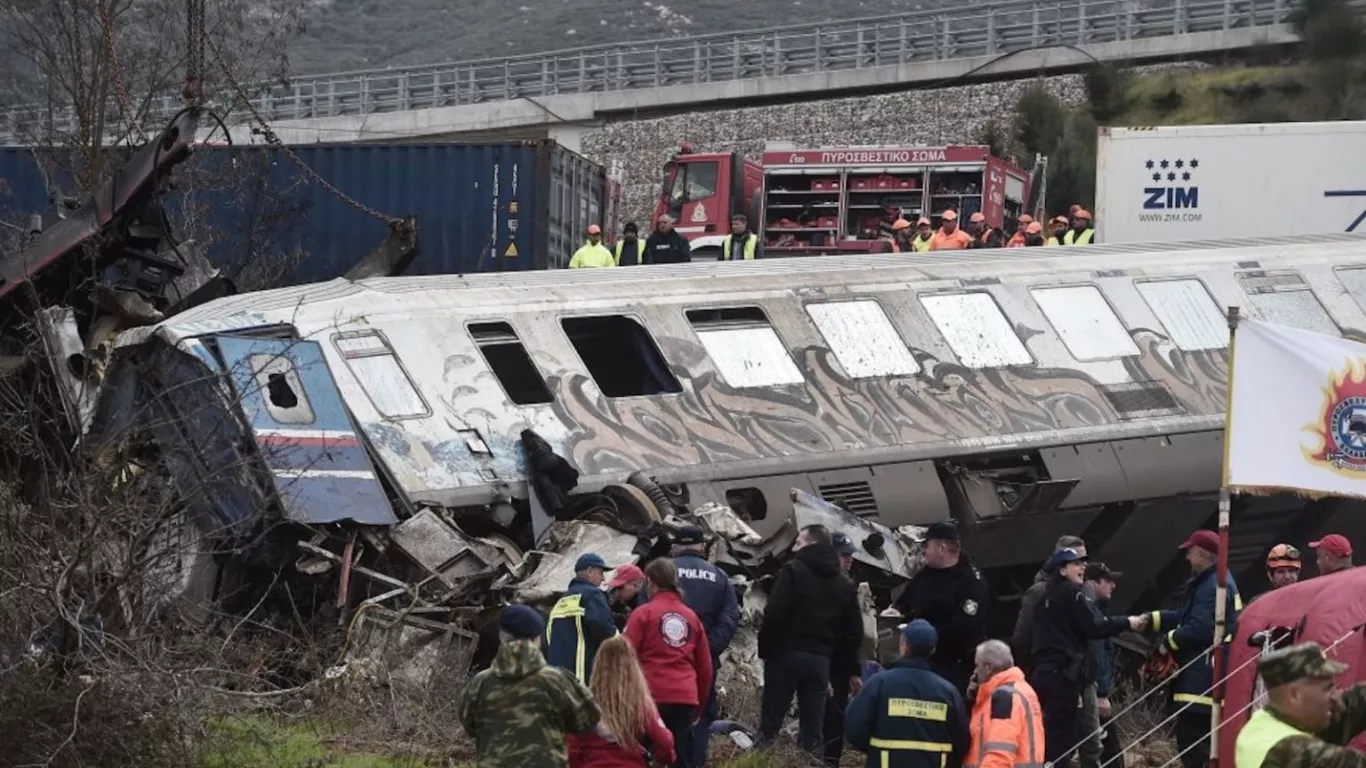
[{"x1": 1224, "y1": 320, "x2": 1366, "y2": 497}]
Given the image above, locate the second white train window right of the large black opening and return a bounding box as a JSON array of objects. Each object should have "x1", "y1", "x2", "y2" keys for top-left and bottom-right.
[{"x1": 806, "y1": 299, "x2": 921, "y2": 379}]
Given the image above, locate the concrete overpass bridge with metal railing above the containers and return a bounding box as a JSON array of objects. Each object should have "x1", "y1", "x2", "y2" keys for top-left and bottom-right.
[{"x1": 0, "y1": 0, "x2": 1322, "y2": 149}]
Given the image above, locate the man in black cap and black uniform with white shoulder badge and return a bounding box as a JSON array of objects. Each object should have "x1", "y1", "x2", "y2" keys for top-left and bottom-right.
[{"x1": 895, "y1": 522, "x2": 990, "y2": 694}]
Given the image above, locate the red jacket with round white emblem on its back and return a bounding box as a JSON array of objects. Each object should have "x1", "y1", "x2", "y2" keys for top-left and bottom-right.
[{"x1": 623, "y1": 592, "x2": 712, "y2": 707}]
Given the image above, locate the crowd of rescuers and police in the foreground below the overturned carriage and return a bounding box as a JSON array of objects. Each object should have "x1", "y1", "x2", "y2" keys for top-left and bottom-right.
[{"x1": 459, "y1": 523, "x2": 1366, "y2": 768}]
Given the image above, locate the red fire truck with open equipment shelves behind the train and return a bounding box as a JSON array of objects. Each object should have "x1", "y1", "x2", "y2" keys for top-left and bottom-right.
[{"x1": 654, "y1": 145, "x2": 1031, "y2": 258}]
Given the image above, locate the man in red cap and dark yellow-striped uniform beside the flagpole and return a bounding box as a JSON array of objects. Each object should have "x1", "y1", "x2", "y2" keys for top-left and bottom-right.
[{"x1": 1150, "y1": 530, "x2": 1243, "y2": 768}]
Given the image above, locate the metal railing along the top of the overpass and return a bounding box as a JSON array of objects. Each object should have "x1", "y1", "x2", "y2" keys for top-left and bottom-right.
[{"x1": 0, "y1": 0, "x2": 1311, "y2": 137}]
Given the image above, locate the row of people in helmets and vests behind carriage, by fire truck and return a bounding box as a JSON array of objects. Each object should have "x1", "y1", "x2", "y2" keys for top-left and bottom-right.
[{"x1": 570, "y1": 205, "x2": 1096, "y2": 269}]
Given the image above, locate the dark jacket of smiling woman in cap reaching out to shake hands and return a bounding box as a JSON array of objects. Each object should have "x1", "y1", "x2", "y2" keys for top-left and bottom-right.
[{"x1": 1030, "y1": 578, "x2": 1128, "y2": 675}]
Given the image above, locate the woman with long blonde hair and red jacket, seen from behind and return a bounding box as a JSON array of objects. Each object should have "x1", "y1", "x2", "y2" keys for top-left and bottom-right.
[{"x1": 568, "y1": 635, "x2": 678, "y2": 768}]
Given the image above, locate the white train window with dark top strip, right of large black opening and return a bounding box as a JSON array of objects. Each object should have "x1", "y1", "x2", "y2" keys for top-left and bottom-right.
[{"x1": 687, "y1": 306, "x2": 806, "y2": 388}]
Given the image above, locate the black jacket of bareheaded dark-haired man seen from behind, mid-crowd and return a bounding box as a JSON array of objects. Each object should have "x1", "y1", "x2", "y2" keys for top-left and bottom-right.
[{"x1": 759, "y1": 544, "x2": 863, "y2": 674}]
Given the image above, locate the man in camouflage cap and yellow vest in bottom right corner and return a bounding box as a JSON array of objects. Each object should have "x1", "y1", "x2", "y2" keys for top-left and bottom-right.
[{"x1": 1233, "y1": 642, "x2": 1366, "y2": 768}]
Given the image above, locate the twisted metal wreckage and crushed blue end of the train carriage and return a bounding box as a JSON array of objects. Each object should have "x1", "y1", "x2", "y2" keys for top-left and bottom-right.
[{"x1": 0, "y1": 108, "x2": 919, "y2": 675}]
